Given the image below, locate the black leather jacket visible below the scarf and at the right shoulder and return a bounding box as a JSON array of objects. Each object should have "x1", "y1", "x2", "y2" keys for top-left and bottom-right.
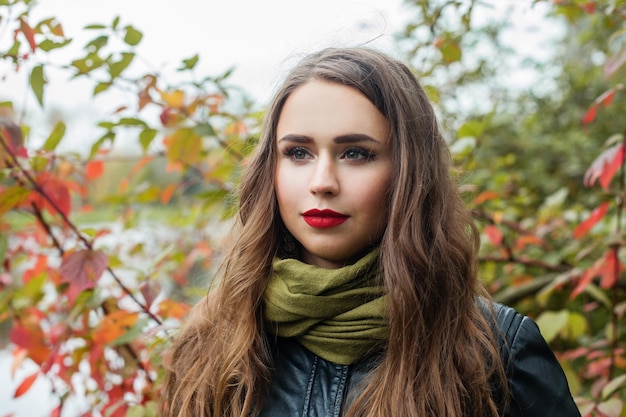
[{"x1": 260, "y1": 305, "x2": 580, "y2": 417}]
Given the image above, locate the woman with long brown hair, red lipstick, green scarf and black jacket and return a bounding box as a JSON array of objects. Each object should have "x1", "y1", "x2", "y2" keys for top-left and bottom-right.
[{"x1": 163, "y1": 48, "x2": 579, "y2": 417}]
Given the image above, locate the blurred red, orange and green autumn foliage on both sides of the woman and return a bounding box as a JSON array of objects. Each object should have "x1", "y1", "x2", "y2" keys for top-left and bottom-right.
[{"x1": 0, "y1": 0, "x2": 626, "y2": 417}]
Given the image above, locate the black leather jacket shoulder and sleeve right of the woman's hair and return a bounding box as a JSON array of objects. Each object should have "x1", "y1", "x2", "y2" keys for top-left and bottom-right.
[{"x1": 493, "y1": 303, "x2": 580, "y2": 417}]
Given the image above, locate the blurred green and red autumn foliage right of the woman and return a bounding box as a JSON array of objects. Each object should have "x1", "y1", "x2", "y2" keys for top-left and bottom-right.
[{"x1": 399, "y1": 0, "x2": 626, "y2": 417}]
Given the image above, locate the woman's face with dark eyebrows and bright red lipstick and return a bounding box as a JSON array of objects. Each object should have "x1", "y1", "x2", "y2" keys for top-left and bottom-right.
[{"x1": 275, "y1": 80, "x2": 392, "y2": 268}]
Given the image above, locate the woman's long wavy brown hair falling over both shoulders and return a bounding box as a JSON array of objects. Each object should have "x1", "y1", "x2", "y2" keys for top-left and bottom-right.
[{"x1": 161, "y1": 48, "x2": 506, "y2": 417}]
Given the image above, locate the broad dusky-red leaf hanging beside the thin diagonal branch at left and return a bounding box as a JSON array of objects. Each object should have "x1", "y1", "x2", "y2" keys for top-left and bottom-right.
[{"x1": 60, "y1": 249, "x2": 109, "y2": 303}]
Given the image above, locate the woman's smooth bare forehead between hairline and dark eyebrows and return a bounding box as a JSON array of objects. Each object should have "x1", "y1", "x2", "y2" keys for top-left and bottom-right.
[{"x1": 277, "y1": 80, "x2": 387, "y2": 143}]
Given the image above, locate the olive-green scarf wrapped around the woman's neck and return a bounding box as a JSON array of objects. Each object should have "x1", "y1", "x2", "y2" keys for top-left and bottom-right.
[{"x1": 265, "y1": 249, "x2": 388, "y2": 365}]
